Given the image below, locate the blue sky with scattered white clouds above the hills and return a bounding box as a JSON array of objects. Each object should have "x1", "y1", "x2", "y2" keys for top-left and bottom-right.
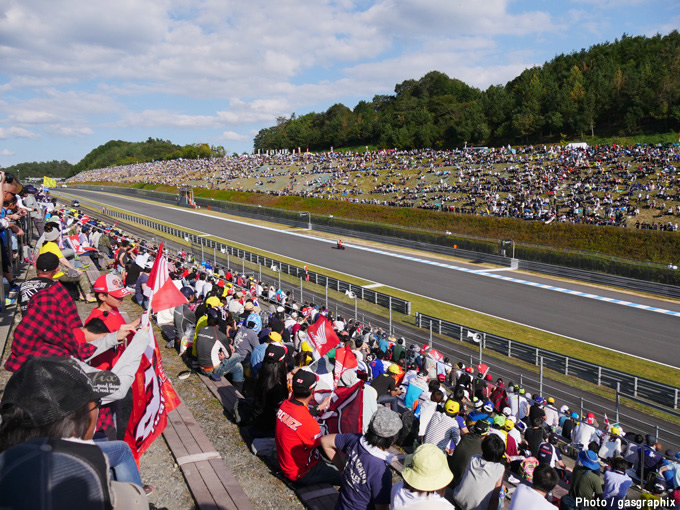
[{"x1": 0, "y1": 0, "x2": 680, "y2": 167}]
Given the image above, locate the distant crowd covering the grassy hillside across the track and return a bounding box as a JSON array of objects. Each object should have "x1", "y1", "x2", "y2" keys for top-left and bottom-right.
[{"x1": 71, "y1": 144, "x2": 680, "y2": 231}]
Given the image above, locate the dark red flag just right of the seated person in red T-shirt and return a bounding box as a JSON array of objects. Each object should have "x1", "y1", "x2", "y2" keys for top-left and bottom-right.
[{"x1": 317, "y1": 381, "x2": 364, "y2": 435}]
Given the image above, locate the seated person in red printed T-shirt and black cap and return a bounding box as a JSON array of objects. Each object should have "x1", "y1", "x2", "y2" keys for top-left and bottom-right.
[{"x1": 275, "y1": 368, "x2": 340, "y2": 485}]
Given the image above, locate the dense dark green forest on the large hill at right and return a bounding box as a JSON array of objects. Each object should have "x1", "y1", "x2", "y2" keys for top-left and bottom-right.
[{"x1": 254, "y1": 31, "x2": 680, "y2": 150}]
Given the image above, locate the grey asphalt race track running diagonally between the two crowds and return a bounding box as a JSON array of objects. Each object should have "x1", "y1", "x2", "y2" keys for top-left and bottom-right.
[{"x1": 67, "y1": 189, "x2": 680, "y2": 367}]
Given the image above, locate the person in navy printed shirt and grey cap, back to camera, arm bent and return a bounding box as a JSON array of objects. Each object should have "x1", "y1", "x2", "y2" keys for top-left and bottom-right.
[{"x1": 321, "y1": 407, "x2": 402, "y2": 510}]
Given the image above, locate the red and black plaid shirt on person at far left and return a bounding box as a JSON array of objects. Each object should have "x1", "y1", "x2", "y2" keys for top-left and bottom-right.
[{"x1": 5, "y1": 282, "x2": 114, "y2": 430}]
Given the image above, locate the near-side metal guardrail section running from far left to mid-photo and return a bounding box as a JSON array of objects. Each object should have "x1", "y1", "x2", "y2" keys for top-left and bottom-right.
[{"x1": 106, "y1": 211, "x2": 411, "y2": 315}]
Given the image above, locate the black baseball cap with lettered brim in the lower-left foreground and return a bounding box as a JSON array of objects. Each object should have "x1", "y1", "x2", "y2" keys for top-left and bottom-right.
[{"x1": 0, "y1": 356, "x2": 120, "y2": 427}]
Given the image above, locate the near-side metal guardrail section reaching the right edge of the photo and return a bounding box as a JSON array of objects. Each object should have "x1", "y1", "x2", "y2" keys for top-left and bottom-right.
[{"x1": 416, "y1": 313, "x2": 680, "y2": 409}]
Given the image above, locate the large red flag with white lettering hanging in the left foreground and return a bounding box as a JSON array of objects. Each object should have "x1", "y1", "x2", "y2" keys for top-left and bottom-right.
[{"x1": 125, "y1": 324, "x2": 181, "y2": 464}]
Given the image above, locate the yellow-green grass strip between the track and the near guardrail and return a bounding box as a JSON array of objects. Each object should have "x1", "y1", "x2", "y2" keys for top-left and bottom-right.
[{"x1": 65, "y1": 190, "x2": 680, "y2": 387}]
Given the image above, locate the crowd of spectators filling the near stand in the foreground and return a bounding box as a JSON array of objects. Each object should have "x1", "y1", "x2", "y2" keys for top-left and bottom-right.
[{"x1": 0, "y1": 189, "x2": 680, "y2": 510}]
